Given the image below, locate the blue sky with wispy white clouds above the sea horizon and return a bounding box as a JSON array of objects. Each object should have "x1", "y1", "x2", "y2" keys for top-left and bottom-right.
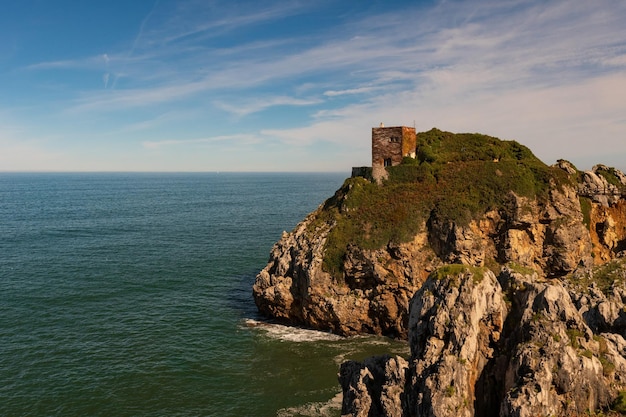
[{"x1": 0, "y1": 0, "x2": 626, "y2": 172}]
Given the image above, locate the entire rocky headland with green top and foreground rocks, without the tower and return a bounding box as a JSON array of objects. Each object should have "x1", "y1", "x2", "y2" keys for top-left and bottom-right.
[{"x1": 253, "y1": 129, "x2": 626, "y2": 417}]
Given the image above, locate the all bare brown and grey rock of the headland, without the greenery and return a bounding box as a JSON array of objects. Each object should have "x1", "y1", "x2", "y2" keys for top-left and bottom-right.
[{"x1": 253, "y1": 155, "x2": 626, "y2": 417}]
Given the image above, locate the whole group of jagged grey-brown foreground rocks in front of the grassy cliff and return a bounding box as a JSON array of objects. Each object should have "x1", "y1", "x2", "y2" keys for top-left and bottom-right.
[{"x1": 341, "y1": 266, "x2": 626, "y2": 417}]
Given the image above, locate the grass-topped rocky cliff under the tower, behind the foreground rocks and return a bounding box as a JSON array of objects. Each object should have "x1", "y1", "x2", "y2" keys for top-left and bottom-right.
[{"x1": 253, "y1": 131, "x2": 626, "y2": 337}]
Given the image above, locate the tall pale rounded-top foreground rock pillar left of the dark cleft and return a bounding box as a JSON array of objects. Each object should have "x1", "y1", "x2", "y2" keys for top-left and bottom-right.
[{"x1": 407, "y1": 265, "x2": 506, "y2": 417}]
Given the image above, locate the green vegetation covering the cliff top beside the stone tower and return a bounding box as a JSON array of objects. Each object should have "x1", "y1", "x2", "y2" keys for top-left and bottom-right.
[{"x1": 319, "y1": 129, "x2": 569, "y2": 278}]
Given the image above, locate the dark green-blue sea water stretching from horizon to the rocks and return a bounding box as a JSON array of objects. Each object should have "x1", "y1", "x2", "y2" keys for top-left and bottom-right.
[{"x1": 0, "y1": 173, "x2": 407, "y2": 416}]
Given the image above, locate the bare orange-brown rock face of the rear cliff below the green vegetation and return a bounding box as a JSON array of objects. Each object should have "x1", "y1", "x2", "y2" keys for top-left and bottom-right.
[{"x1": 253, "y1": 158, "x2": 626, "y2": 337}]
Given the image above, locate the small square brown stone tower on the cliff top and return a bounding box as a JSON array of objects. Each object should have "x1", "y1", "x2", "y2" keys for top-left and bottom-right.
[{"x1": 372, "y1": 123, "x2": 416, "y2": 182}]
